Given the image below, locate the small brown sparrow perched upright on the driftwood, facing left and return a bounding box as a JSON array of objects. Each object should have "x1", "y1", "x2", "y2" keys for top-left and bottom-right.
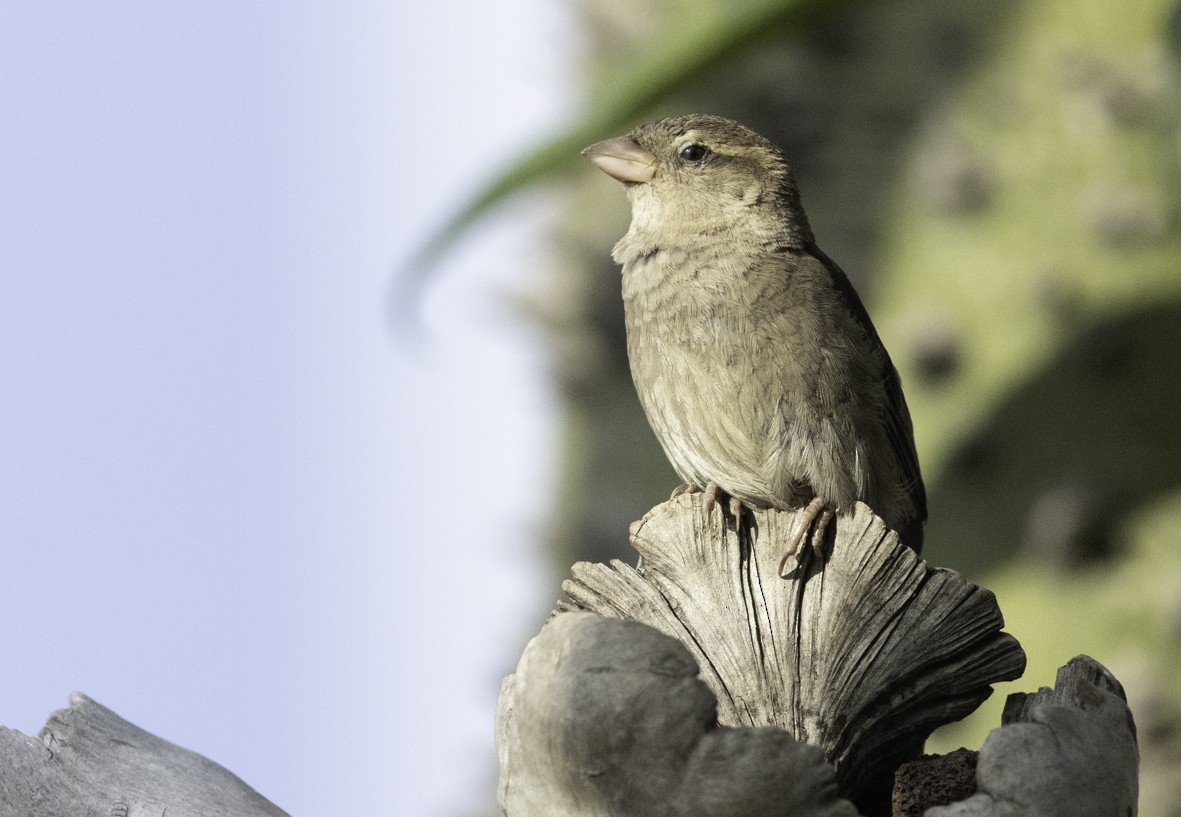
[{"x1": 582, "y1": 113, "x2": 927, "y2": 576}]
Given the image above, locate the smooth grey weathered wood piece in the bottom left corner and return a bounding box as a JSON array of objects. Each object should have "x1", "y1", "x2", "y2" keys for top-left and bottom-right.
[{"x1": 0, "y1": 694, "x2": 286, "y2": 817}]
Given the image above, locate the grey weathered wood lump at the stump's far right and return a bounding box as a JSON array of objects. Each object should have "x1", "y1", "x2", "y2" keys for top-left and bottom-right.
[{"x1": 927, "y1": 655, "x2": 1140, "y2": 817}]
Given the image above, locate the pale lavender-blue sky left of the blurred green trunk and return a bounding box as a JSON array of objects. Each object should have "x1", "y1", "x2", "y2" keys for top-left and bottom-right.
[{"x1": 0, "y1": 0, "x2": 572, "y2": 817}]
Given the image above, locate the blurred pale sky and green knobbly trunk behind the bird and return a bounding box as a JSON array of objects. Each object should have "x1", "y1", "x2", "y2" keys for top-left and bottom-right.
[{"x1": 0, "y1": 0, "x2": 1181, "y2": 817}]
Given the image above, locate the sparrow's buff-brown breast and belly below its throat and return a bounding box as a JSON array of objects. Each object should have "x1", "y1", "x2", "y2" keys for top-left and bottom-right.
[{"x1": 624, "y1": 240, "x2": 877, "y2": 506}]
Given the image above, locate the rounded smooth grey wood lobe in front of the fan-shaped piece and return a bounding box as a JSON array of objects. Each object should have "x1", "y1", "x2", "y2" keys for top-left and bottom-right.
[{"x1": 496, "y1": 613, "x2": 856, "y2": 817}]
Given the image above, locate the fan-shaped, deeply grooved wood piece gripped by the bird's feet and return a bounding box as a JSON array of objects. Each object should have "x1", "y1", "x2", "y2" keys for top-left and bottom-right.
[{"x1": 563, "y1": 495, "x2": 1025, "y2": 813}]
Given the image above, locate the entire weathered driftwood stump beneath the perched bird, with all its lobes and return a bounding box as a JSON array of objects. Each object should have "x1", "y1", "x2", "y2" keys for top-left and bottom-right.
[{"x1": 497, "y1": 496, "x2": 1136, "y2": 817}]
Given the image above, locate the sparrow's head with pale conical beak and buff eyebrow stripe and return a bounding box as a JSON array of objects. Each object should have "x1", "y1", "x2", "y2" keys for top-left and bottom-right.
[{"x1": 582, "y1": 113, "x2": 811, "y2": 243}]
